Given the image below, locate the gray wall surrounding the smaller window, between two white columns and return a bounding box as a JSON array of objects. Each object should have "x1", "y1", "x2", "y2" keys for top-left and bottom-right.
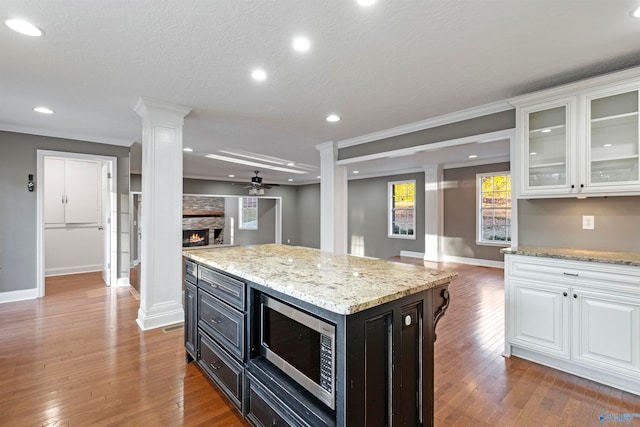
[{"x1": 347, "y1": 173, "x2": 424, "y2": 259}]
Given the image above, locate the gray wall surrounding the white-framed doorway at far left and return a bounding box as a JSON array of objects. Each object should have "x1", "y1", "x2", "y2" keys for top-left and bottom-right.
[{"x1": 0, "y1": 131, "x2": 129, "y2": 292}]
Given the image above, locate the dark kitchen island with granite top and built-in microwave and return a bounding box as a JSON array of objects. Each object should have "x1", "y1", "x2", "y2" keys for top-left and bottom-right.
[{"x1": 183, "y1": 245, "x2": 457, "y2": 427}]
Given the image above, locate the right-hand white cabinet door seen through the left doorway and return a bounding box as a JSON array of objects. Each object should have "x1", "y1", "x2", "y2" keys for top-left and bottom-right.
[{"x1": 64, "y1": 160, "x2": 101, "y2": 223}]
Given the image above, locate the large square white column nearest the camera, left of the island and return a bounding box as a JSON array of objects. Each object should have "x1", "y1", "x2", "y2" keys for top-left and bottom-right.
[{"x1": 134, "y1": 99, "x2": 191, "y2": 330}]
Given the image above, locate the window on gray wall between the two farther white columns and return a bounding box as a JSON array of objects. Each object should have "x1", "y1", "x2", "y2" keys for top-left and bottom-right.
[{"x1": 389, "y1": 180, "x2": 416, "y2": 239}]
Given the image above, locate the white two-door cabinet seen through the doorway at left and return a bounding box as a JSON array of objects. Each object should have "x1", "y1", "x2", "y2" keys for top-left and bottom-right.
[{"x1": 44, "y1": 158, "x2": 101, "y2": 224}]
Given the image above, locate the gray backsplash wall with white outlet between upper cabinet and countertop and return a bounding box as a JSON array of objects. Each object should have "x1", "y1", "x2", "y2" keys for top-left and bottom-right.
[{"x1": 518, "y1": 196, "x2": 640, "y2": 253}]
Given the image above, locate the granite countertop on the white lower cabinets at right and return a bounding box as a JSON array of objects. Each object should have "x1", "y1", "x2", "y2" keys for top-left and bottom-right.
[{"x1": 500, "y1": 245, "x2": 640, "y2": 267}]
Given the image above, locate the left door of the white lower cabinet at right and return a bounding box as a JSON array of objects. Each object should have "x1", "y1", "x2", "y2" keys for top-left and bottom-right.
[{"x1": 511, "y1": 280, "x2": 569, "y2": 358}]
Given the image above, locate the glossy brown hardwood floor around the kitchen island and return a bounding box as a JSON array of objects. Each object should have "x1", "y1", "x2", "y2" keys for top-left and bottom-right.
[{"x1": 0, "y1": 266, "x2": 640, "y2": 426}]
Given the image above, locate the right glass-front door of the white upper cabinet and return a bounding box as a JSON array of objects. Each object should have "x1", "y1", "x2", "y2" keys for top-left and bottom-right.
[{"x1": 583, "y1": 90, "x2": 640, "y2": 192}]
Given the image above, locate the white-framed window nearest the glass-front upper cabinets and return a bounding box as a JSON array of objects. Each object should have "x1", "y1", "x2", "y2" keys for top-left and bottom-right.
[{"x1": 476, "y1": 172, "x2": 511, "y2": 246}]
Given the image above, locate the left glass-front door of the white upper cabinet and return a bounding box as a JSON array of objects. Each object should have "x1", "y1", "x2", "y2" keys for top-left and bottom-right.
[{"x1": 519, "y1": 98, "x2": 576, "y2": 195}]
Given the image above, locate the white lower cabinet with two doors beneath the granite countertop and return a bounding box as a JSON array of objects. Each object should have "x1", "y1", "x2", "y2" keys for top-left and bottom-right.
[{"x1": 505, "y1": 255, "x2": 640, "y2": 394}]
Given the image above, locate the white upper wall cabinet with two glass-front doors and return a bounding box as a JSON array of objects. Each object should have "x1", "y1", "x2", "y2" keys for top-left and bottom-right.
[{"x1": 512, "y1": 78, "x2": 640, "y2": 198}]
